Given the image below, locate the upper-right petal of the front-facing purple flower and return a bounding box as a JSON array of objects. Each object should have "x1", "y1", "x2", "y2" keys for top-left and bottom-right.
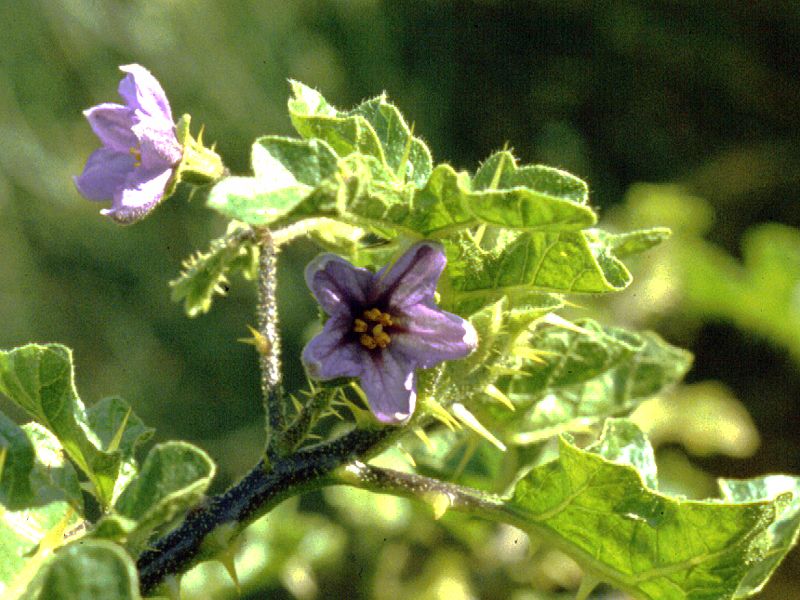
[{"x1": 374, "y1": 242, "x2": 447, "y2": 310}]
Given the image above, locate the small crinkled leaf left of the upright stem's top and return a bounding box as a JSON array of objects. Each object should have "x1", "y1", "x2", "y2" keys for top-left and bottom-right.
[{"x1": 169, "y1": 226, "x2": 258, "y2": 317}]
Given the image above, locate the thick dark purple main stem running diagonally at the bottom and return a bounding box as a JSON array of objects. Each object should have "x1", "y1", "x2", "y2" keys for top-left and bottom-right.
[{"x1": 137, "y1": 427, "x2": 402, "y2": 594}]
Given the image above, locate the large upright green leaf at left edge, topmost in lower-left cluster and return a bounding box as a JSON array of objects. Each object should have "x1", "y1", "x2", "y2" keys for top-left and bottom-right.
[{"x1": 0, "y1": 344, "x2": 120, "y2": 505}]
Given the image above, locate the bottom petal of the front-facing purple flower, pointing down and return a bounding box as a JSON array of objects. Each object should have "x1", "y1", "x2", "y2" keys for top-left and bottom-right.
[{"x1": 361, "y1": 350, "x2": 417, "y2": 424}]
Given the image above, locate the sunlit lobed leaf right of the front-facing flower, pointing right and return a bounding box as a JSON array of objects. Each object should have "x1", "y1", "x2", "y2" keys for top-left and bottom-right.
[{"x1": 507, "y1": 321, "x2": 692, "y2": 444}]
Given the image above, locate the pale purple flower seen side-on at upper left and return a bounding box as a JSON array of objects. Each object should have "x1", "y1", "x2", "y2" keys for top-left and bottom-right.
[{"x1": 74, "y1": 65, "x2": 183, "y2": 223}]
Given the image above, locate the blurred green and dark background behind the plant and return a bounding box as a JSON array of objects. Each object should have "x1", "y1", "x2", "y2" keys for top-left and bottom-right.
[{"x1": 0, "y1": 0, "x2": 800, "y2": 600}]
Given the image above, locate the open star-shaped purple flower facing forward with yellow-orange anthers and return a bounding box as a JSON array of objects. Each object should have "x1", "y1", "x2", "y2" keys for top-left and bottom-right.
[{"x1": 303, "y1": 242, "x2": 478, "y2": 423}]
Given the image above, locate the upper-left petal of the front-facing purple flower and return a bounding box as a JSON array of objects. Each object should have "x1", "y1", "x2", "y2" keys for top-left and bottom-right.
[{"x1": 305, "y1": 254, "x2": 374, "y2": 315}]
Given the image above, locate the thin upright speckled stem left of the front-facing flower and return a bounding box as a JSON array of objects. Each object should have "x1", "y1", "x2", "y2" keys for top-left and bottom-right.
[{"x1": 256, "y1": 227, "x2": 286, "y2": 456}]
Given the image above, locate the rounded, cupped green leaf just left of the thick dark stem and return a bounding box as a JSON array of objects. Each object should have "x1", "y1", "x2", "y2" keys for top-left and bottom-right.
[{"x1": 114, "y1": 442, "x2": 215, "y2": 549}]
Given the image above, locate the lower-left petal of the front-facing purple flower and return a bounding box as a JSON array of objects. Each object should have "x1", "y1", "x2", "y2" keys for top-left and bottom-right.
[{"x1": 302, "y1": 314, "x2": 367, "y2": 379}]
